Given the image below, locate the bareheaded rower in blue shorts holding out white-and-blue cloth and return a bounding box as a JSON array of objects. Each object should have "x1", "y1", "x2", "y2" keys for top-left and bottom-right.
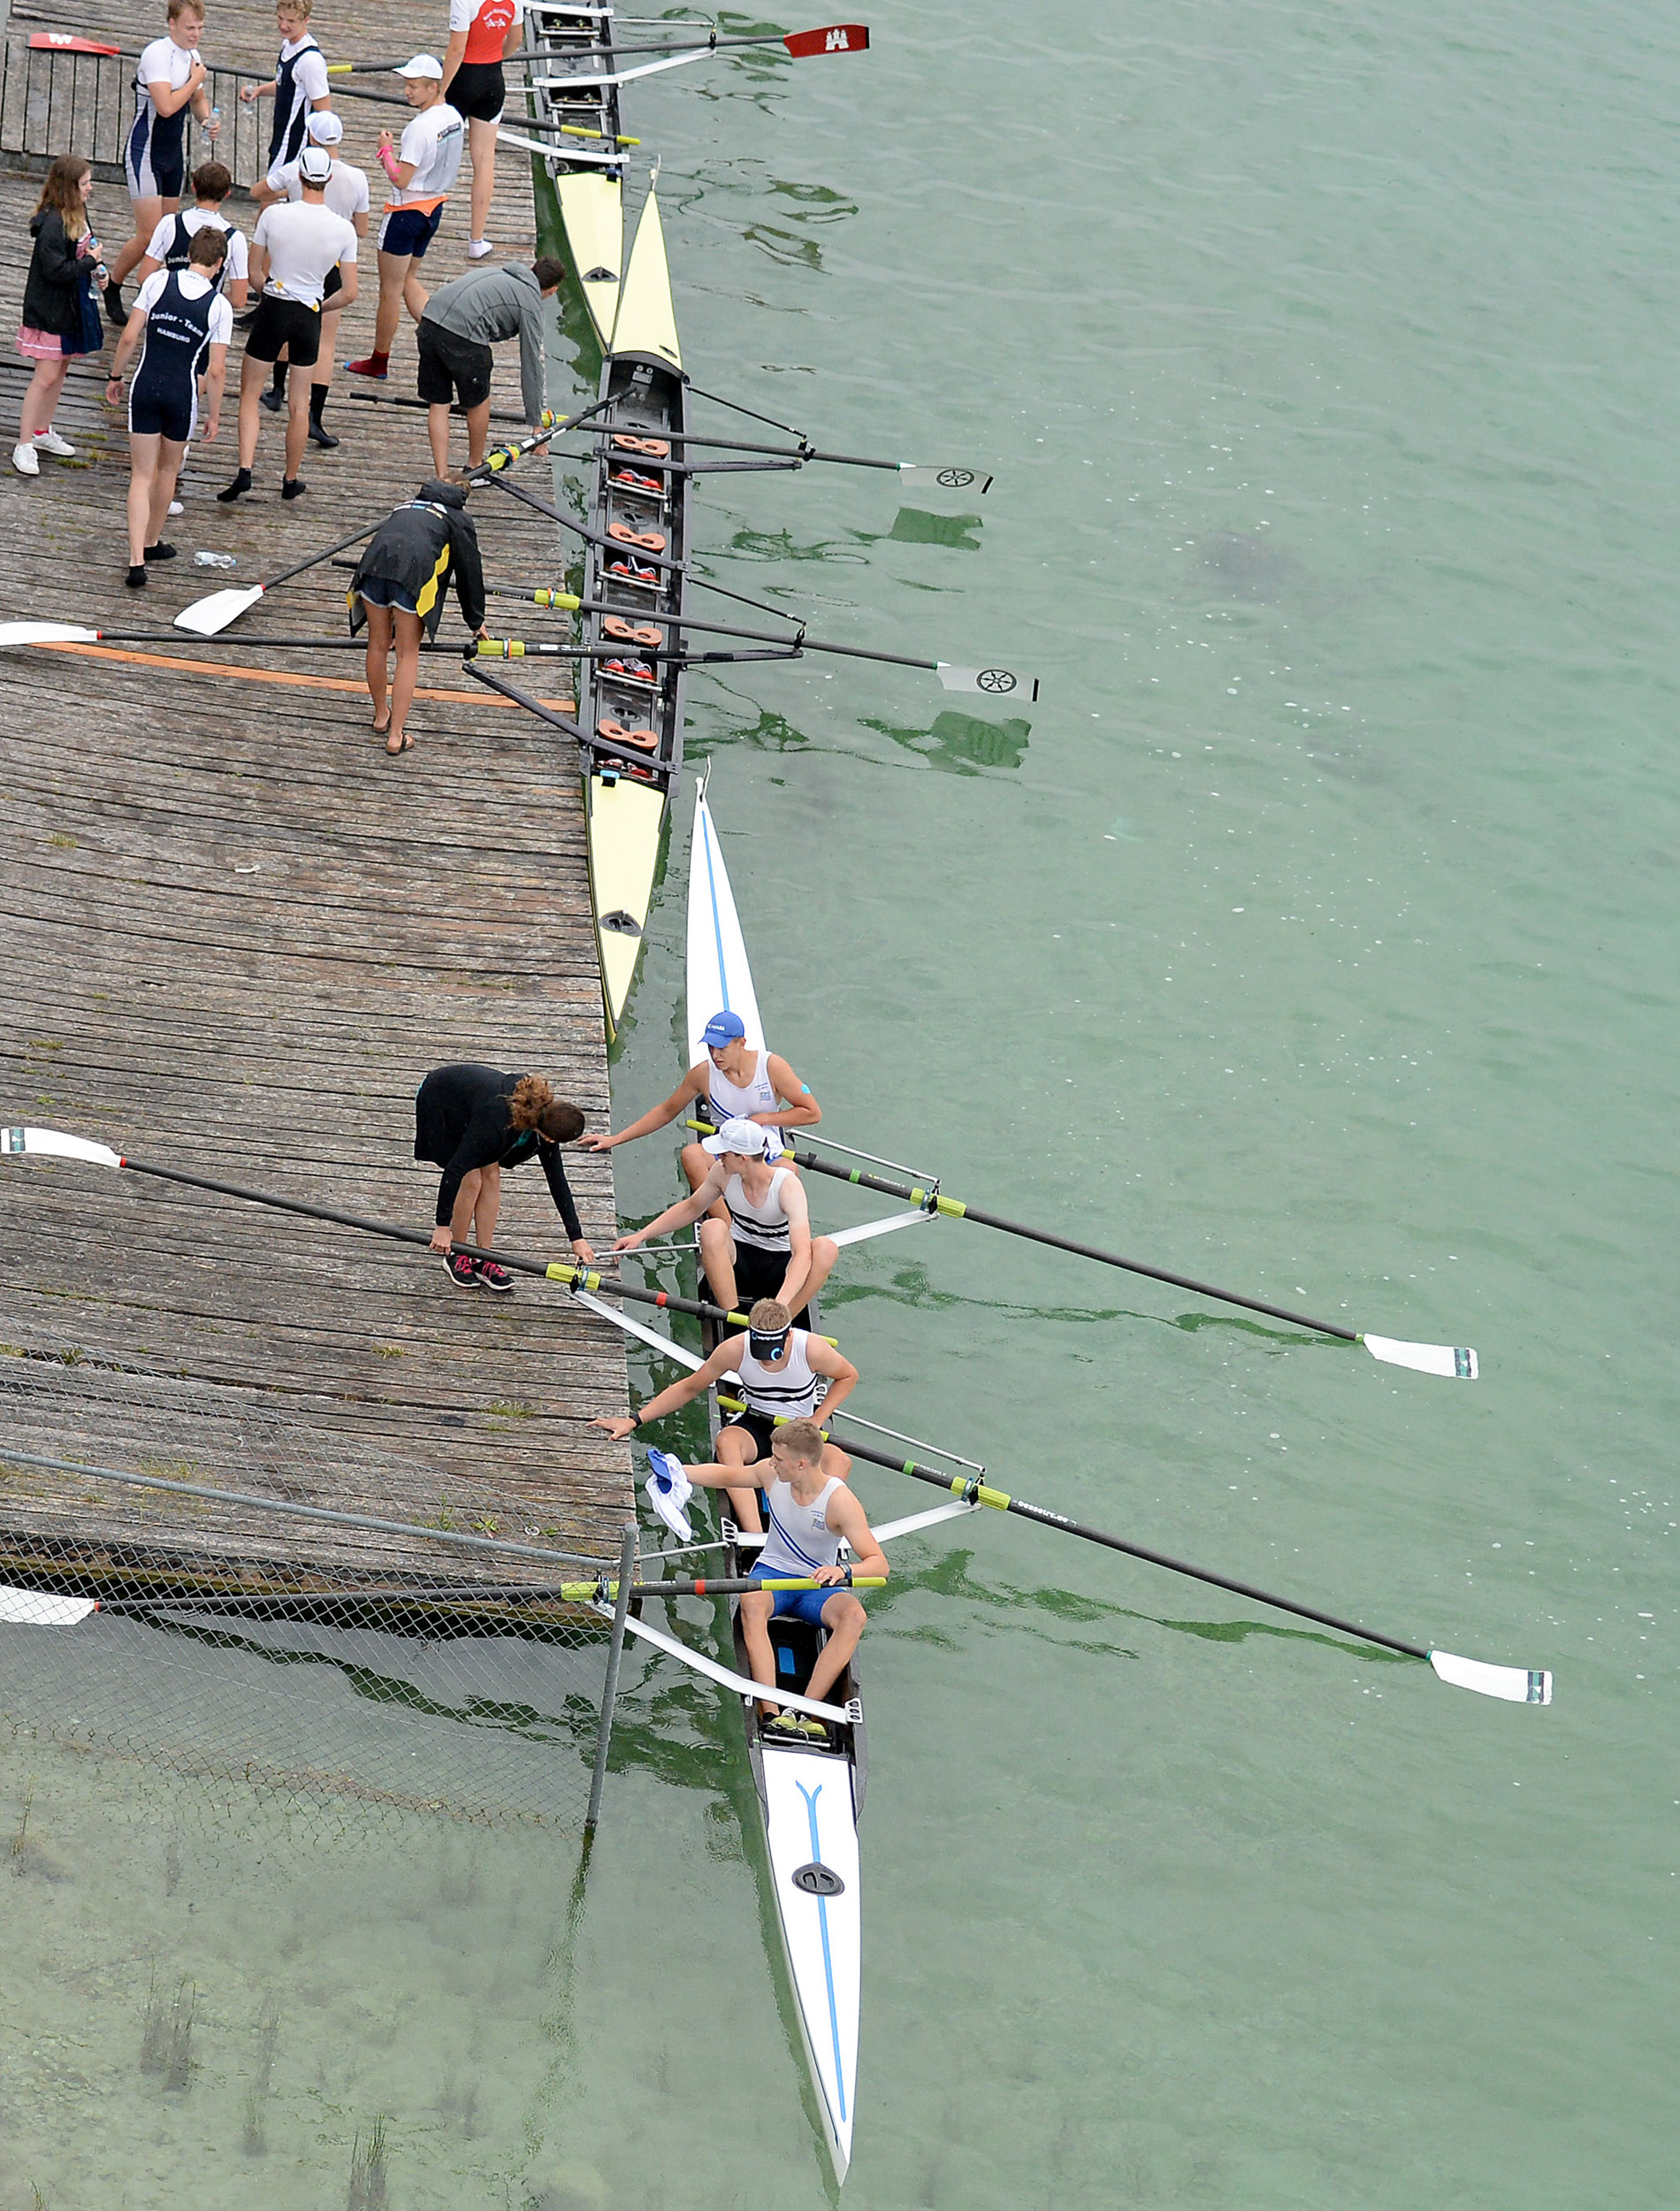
[{"x1": 648, "y1": 1419, "x2": 889, "y2": 1740}]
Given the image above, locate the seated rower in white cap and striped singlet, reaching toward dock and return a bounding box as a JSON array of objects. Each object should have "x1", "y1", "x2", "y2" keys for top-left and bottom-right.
[{"x1": 613, "y1": 1121, "x2": 840, "y2": 1320}]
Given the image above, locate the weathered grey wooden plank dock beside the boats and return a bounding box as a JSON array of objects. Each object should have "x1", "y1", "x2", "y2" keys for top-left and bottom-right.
[{"x1": 0, "y1": 0, "x2": 632, "y2": 1581}]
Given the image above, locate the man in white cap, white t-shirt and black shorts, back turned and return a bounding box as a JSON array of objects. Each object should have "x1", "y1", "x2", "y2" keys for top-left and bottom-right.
[{"x1": 217, "y1": 146, "x2": 358, "y2": 507}]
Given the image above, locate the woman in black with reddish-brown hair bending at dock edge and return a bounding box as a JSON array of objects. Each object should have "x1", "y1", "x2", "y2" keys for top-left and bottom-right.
[{"x1": 414, "y1": 1060, "x2": 595, "y2": 1296}]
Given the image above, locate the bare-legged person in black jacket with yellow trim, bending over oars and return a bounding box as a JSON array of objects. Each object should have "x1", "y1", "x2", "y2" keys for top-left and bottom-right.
[{"x1": 347, "y1": 478, "x2": 486, "y2": 759}]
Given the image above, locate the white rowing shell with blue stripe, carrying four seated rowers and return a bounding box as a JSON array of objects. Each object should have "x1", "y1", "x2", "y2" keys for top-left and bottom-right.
[{"x1": 688, "y1": 787, "x2": 867, "y2": 2183}]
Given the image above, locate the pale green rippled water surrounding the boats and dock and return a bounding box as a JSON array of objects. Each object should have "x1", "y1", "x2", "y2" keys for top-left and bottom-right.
[{"x1": 0, "y1": 0, "x2": 1680, "y2": 2211}]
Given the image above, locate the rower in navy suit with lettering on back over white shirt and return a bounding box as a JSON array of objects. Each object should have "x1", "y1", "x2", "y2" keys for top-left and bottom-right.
[{"x1": 106, "y1": 226, "x2": 234, "y2": 591}]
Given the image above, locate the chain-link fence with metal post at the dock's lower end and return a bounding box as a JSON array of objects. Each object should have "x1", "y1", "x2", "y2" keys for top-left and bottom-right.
[{"x1": 0, "y1": 1343, "x2": 637, "y2": 1840}]
